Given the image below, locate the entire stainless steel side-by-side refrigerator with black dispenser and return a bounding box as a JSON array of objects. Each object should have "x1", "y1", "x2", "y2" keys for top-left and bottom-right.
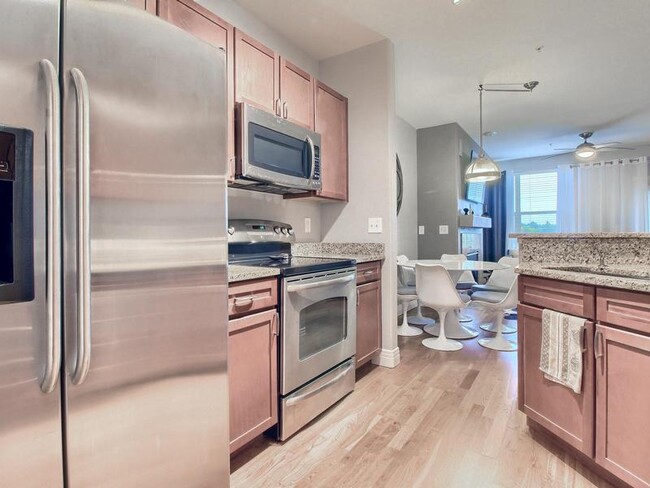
[{"x1": 0, "y1": 0, "x2": 229, "y2": 488}]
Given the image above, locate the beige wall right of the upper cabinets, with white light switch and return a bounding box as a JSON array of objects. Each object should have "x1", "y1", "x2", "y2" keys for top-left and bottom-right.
[{"x1": 319, "y1": 40, "x2": 399, "y2": 366}]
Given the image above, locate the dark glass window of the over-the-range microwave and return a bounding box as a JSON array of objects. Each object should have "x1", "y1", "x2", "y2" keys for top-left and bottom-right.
[{"x1": 248, "y1": 123, "x2": 310, "y2": 178}]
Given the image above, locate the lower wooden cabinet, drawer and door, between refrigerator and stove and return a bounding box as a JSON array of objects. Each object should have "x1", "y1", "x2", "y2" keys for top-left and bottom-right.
[{"x1": 228, "y1": 278, "x2": 279, "y2": 453}]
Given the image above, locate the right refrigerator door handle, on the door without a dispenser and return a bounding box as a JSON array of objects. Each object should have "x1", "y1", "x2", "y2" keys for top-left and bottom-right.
[{"x1": 70, "y1": 68, "x2": 92, "y2": 385}]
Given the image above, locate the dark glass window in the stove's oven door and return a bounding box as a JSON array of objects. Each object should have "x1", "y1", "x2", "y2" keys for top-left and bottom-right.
[{"x1": 299, "y1": 297, "x2": 348, "y2": 361}]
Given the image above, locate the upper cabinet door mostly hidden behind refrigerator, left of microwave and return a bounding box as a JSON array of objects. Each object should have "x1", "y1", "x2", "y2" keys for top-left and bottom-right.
[{"x1": 158, "y1": 0, "x2": 235, "y2": 180}]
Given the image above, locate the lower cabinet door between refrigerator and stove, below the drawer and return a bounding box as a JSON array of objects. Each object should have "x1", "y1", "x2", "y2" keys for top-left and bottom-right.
[{"x1": 228, "y1": 309, "x2": 278, "y2": 452}]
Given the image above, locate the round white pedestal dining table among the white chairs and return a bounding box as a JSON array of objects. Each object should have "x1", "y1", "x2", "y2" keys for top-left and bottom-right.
[{"x1": 402, "y1": 259, "x2": 510, "y2": 340}]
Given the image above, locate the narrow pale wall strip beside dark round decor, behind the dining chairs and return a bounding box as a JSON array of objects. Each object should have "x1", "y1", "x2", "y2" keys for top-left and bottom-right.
[{"x1": 395, "y1": 117, "x2": 418, "y2": 259}]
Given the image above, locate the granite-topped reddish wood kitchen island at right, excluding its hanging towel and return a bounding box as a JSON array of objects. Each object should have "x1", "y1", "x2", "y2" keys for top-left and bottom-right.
[{"x1": 512, "y1": 234, "x2": 650, "y2": 488}]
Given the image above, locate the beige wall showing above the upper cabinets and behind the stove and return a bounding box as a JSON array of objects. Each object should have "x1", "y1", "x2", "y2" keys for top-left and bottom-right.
[{"x1": 197, "y1": 0, "x2": 321, "y2": 234}]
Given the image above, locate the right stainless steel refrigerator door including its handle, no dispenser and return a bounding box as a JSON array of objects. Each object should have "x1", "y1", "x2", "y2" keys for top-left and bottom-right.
[{"x1": 62, "y1": 0, "x2": 229, "y2": 488}]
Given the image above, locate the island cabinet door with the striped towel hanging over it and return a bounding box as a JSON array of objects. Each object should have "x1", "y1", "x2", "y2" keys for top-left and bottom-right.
[{"x1": 518, "y1": 304, "x2": 595, "y2": 457}]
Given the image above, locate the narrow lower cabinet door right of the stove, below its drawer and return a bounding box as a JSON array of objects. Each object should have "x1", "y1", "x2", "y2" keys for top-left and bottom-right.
[{"x1": 357, "y1": 281, "x2": 381, "y2": 368}]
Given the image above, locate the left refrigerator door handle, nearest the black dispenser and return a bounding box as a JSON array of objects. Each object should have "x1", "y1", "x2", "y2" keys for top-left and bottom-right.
[{"x1": 40, "y1": 59, "x2": 61, "y2": 393}]
